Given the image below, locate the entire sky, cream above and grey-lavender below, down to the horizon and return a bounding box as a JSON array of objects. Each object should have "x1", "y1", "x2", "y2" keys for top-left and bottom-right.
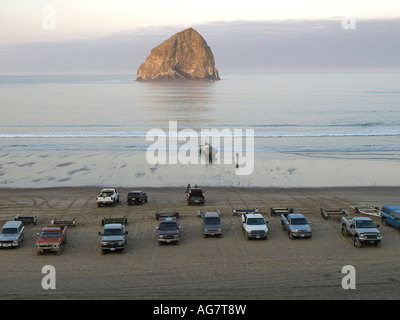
[{"x1": 0, "y1": 0, "x2": 400, "y2": 74}]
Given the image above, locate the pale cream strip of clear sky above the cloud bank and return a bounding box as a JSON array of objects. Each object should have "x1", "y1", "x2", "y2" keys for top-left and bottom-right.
[{"x1": 0, "y1": 0, "x2": 400, "y2": 44}]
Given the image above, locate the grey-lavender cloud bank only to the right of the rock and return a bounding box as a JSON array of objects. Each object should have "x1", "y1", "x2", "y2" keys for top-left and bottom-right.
[{"x1": 199, "y1": 18, "x2": 400, "y2": 71}]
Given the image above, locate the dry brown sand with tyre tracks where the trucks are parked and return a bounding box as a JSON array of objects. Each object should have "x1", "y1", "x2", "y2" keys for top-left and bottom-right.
[{"x1": 0, "y1": 184, "x2": 400, "y2": 300}]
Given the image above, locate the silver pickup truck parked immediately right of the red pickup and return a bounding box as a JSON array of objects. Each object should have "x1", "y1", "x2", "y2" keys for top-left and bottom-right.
[{"x1": 99, "y1": 223, "x2": 128, "y2": 254}]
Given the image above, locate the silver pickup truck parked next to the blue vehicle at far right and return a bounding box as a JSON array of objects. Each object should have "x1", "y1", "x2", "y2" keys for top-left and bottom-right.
[{"x1": 342, "y1": 217, "x2": 382, "y2": 248}]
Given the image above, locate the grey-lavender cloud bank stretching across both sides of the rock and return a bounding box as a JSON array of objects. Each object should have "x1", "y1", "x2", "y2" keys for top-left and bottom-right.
[{"x1": 0, "y1": 18, "x2": 400, "y2": 76}]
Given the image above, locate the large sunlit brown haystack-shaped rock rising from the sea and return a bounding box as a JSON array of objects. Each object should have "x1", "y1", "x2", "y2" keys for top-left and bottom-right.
[{"x1": 137, "y1": 28, "x2": 220, "y2": 81}]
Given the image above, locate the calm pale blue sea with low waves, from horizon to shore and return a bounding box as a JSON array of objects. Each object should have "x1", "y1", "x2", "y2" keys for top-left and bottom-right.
[{"x1": 0, "y1": 72, "x2": 400, "y2": 153}]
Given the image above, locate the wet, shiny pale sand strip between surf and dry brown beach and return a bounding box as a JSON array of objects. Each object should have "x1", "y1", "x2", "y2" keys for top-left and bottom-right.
[{"x1": 0, "y1": 150, "x2": 400, "y2": 189}]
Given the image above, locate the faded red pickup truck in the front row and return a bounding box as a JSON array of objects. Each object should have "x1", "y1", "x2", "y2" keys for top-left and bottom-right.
[{"x1": 36, "y1": 226, "x2": 67, "y2": 255}]
